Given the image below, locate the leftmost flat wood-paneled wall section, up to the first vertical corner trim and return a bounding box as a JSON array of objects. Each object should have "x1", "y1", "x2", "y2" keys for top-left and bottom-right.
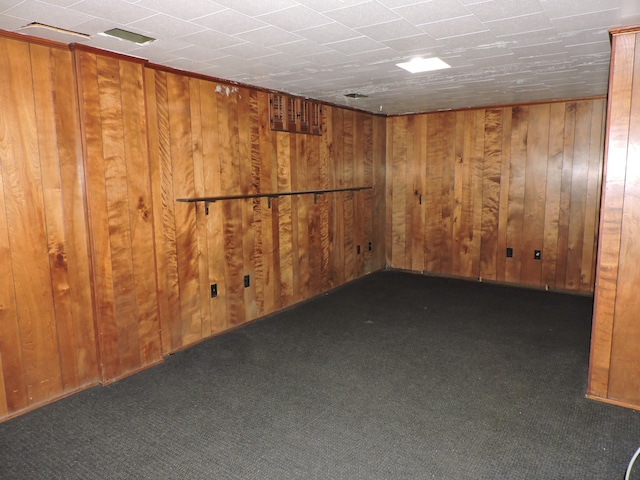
[{"x1": 0, "y1": 37, "x2": 98, "y2": 418}]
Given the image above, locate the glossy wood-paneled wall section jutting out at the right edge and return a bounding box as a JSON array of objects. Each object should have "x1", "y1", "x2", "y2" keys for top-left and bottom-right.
[{"x1": 588, "y1": 28, "x2": 640, "y2": 408}]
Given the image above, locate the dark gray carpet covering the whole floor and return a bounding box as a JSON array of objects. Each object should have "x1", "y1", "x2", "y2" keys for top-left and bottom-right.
[{"x1": 0, "y1": 272, "x2": 640, "y2": 480}]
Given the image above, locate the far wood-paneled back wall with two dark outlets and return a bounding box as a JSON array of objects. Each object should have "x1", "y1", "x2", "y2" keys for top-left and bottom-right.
[{"x1": 386, "y1": 99, "x2": 605, "y2": 292}]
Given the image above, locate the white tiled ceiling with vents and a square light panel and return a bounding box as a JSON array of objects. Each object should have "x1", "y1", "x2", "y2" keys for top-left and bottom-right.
[{"x1": 0, "y1": 0, "x2": 640, "y2": 114}]
